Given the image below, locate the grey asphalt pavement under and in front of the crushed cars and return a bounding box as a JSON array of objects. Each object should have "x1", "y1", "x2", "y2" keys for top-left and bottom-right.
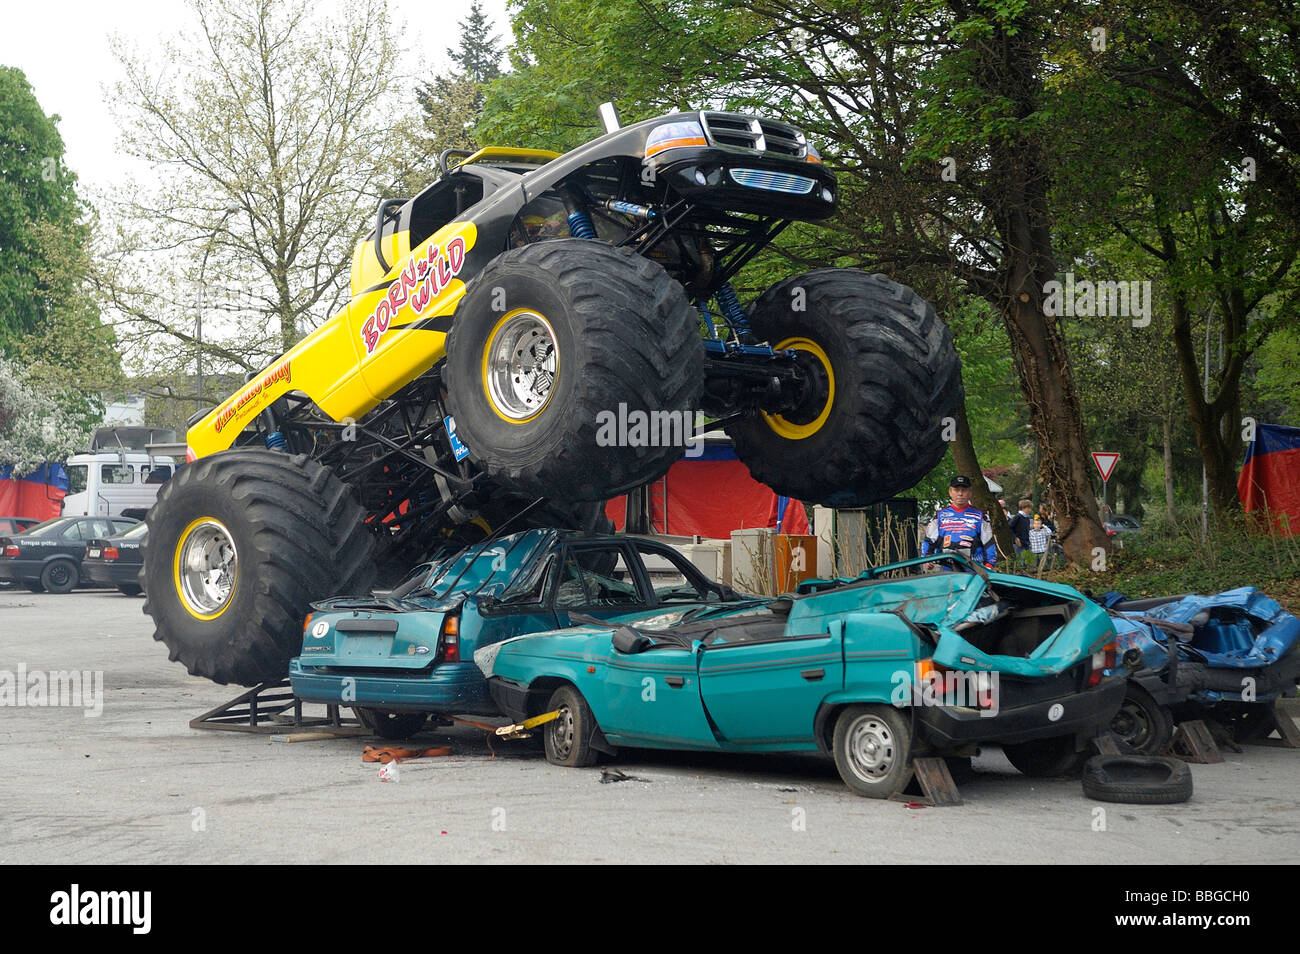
[{"x1": 0, "y1": 590, "x2": 1300, "y2": 864}]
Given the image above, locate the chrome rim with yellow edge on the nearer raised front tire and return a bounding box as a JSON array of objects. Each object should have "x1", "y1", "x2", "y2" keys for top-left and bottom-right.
[{"x1": 486, "y1": 312, "x2": 559, "y2": 421}]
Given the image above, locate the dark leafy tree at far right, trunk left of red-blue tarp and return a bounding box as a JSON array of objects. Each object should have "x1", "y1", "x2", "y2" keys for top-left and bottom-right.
[{"x1": 1095, "y1": 0, "x2": 1300, "y2": 515}]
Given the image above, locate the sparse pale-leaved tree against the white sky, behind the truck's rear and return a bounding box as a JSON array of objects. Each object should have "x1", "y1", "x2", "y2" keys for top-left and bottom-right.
[{"x1": 101, "y1": 0, "x2": 410, "y2": 402}]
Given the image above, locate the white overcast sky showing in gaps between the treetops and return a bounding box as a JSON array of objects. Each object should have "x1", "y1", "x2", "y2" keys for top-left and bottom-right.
[{"x1": 0, "y1": 0, "x2": 510, "y2": 195}]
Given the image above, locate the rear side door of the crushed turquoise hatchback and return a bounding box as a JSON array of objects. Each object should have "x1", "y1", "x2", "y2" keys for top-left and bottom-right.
[{"x1": 699, "y1": 608, "x2": 844, "y2": 747}]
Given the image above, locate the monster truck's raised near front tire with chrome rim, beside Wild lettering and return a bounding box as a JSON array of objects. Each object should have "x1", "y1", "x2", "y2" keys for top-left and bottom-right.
[{"x1": 445, "y1": 239, "x2": 705, "y2": 502}]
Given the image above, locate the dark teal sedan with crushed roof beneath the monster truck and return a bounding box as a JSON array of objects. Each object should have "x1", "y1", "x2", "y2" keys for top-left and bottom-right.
[{"x1": 289, "y1": 530, "x2": 737, "y2": 738}]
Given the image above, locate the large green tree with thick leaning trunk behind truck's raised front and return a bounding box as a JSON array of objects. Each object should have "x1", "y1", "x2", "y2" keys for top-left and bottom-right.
[{"x1": 484, "y1": 0, "x2": 1106, "y2": 560}]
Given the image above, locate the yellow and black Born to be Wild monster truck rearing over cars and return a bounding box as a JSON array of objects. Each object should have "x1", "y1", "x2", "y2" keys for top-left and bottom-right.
[{"x1": 143, "y1": 112, "x2": 961, "y2": 685}]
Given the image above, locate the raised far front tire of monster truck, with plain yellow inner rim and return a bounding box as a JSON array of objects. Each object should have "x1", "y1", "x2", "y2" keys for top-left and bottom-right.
[{"x1": 727, "y1": 268, "x2": 962, "y2": 507}]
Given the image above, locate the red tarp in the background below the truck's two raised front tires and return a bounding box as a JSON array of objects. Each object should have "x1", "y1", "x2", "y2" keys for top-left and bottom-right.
[{"x1": 605, "y1": 445, "x2": 809, "y2": 539}]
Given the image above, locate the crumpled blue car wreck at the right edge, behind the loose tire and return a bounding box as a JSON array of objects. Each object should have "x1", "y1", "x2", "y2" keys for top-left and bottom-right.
[{"x1": 1101, "y1": 586, "x2": 1300, "y2": 755}]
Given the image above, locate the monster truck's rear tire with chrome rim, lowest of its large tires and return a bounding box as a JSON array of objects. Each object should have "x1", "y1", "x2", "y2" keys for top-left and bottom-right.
[{"x1": 143, "y1": 450, "x2": 374, "y2": 686}]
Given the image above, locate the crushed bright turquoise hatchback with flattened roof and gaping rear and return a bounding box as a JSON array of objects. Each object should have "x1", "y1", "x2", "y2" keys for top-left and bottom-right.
[{"x1": 475, "y1": 555, "x2": 1125, "y2": 798}]
